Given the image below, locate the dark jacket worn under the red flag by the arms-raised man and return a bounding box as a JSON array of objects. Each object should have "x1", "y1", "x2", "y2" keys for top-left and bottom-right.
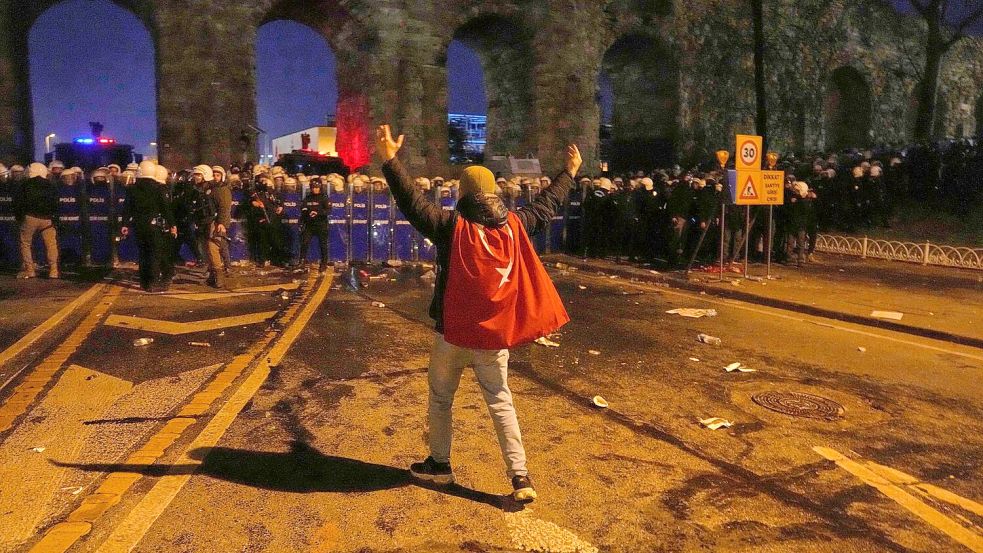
[{"x1": 382, "y1": 157, "x2": 573, "y2": 333}]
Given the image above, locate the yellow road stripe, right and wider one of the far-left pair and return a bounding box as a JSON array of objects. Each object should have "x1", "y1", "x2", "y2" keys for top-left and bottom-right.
[{"x1": 0, "y1": 286, "x2": 123, "y2": 432}]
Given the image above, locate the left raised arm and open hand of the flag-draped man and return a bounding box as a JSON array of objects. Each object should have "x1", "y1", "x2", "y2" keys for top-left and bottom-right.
[{"x1": 376, "y1": 125, "x2": 453, "y2": 241}]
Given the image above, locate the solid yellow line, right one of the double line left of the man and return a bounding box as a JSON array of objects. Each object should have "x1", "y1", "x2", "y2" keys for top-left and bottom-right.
[{"x1": 96, "y1": 273, "x2": 334, "y2": 553}]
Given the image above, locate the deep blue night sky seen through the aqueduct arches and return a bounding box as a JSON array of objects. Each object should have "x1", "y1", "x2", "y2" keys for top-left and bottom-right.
[{"x1": 29, "y1": 0, "x2": 983, "y2": 157}]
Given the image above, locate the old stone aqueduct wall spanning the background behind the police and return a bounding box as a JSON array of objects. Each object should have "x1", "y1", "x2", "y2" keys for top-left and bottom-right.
[{"x1": 0, "y1": 0, "x2": 983, "y2": 174}]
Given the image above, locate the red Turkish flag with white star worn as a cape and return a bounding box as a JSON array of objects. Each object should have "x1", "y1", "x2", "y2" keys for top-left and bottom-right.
[{"x1": 444, "y1": 213, "x2": 570, "y2": 349}]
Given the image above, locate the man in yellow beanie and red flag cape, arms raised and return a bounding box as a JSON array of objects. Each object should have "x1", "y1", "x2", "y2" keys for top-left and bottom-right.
[{"x1": 376, "y1": 125, "x2": 582, "y2": 501}]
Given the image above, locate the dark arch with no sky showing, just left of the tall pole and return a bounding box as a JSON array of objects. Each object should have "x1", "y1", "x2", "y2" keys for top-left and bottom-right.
[{"x1": 598, "y1": 34, "x2": 679, "y2": 171}]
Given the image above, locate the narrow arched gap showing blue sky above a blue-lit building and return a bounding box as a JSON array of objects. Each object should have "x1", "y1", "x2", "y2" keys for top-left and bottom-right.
[{"x1": 447, "y1": 40, "x2": 488, "y2": 164}]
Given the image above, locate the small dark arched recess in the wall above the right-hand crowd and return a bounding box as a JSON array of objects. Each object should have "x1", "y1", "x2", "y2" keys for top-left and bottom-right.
[{"x1": 826, "y1": 67, "x2": 872, "y2": 150}]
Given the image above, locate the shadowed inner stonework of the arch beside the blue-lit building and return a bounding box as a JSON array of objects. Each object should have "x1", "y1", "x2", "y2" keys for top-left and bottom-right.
[{"x1": 452, "y1": 14, "x2": 537, "y2": 156}]
